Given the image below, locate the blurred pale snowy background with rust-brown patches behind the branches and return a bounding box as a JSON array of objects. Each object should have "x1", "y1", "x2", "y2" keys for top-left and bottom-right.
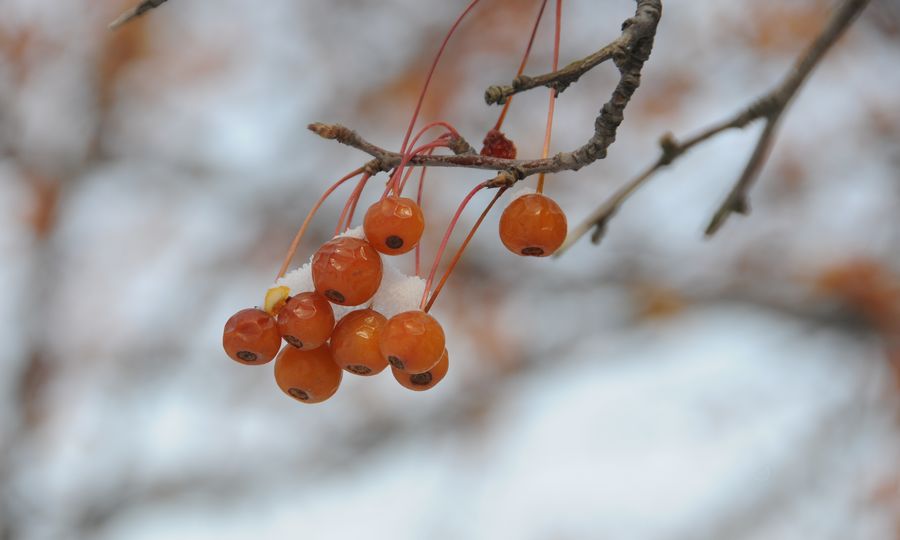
[{"x1": 0, "y1": 0, "x2": 900, "y2": 540}]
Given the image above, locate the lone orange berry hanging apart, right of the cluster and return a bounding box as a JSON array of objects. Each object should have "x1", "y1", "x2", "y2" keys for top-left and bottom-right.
[{"x1": 500, "y1": 193, "x2": 568, "y2": 257}]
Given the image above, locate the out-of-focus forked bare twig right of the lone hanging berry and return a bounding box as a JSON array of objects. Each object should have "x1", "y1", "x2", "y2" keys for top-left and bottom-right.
[{"x1": 556, "y1": 0, "x2": 869, "y2": 255}]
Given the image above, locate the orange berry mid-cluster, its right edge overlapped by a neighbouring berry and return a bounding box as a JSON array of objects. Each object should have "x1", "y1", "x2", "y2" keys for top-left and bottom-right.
[{"x1": 331, "y1": 309, "x2": 387, "y2": 376}]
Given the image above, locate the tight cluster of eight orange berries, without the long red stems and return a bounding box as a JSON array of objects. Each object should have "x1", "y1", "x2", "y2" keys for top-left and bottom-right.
[{"x1": 222, "y1": 204, "x2": 448, "y2": 403}]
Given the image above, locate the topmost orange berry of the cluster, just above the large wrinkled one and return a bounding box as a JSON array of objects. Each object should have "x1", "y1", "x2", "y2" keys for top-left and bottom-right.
[{"x1": 363, "y1": 197, "x2": 425, "y2": 255}]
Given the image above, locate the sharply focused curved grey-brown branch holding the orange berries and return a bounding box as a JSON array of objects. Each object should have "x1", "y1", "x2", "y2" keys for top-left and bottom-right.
[{"x1": 309, "y1": 0, "x2": 662, "y2": 187}]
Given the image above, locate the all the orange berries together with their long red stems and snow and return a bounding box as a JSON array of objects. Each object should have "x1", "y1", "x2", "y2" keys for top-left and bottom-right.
[{"x1": 222, "y1": 0, "x2": 567, "y2": 403}]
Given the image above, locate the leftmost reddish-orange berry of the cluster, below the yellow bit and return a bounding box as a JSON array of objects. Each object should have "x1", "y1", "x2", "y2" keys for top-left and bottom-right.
[{"x1": 222, "y1": 308, "x2": 281, "y2": 366}]
